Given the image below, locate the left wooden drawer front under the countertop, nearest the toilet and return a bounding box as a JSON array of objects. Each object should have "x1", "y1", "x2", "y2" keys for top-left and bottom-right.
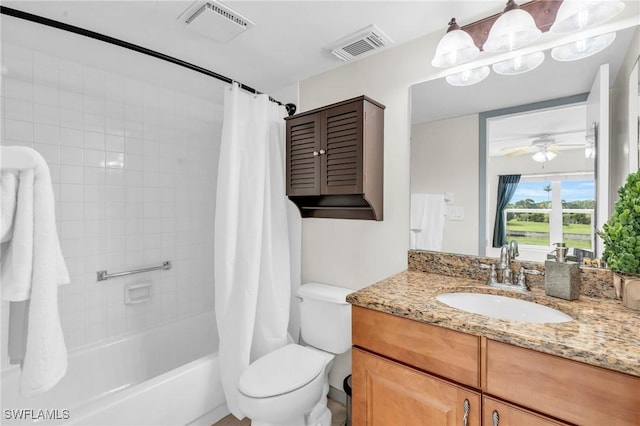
[{"x1": 352, "y1": 306, "x2": 480, "y2": 388}]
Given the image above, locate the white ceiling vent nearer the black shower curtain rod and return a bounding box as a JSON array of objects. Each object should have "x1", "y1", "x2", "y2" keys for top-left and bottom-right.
[{"x1": 185, "y1": 1, "x2": 254, "y2": 43}]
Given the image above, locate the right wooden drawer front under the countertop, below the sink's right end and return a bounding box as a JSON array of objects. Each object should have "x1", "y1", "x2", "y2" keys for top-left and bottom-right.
[{"x1": 486, "y1": 340, "x2": 640, "y2": 426}]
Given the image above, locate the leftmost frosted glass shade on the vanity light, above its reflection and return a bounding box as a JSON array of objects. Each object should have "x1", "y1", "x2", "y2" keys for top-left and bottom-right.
[{"x1": 431, "y1": 18, "x2": 480, "y2": 68}]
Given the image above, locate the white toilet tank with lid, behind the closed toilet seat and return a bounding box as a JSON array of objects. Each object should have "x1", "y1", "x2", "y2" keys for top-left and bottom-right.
[{"x1": 298, "y1": 283, "x2": 354, "y2": 354}]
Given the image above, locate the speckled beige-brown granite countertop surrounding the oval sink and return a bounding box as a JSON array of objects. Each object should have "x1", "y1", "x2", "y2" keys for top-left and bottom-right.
[{"x1": 347, "y1": 271, "x2": 640, "y2": 377}]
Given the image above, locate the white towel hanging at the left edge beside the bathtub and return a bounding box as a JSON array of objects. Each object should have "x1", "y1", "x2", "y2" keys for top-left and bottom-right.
[{"x1": 0, "y1": 148, "x2": 69, "y2": 396}]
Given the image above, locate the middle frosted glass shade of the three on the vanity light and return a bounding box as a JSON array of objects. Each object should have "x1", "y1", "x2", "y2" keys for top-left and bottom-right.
[{"x1": 482, "y1": 0, "x2": 542, "y2": 52}]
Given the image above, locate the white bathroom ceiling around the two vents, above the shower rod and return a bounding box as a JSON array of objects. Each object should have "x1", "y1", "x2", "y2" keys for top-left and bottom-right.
[{"x1": 3, "y1": 0, "x2": 505, "y2": 102}]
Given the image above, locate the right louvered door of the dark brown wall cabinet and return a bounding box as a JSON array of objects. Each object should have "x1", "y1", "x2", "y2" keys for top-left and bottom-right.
[{"x1": 320, "y1": 101, "x2": 363, "y2": 195}]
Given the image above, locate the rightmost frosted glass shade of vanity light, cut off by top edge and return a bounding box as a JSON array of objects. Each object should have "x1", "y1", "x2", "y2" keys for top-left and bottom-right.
[{"x1": 549, "y1": 0, "x2": 625, "y2": 34}]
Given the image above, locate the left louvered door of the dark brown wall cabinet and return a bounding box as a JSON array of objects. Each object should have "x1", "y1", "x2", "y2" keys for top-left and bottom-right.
[{"x1": 287, "y1": 114, "x2": 320, "y2": 195}]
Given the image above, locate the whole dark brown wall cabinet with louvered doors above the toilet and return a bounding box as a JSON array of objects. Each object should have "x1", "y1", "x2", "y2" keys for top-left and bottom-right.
[{"x1": 286, "y1": 96, "x2": 385, "y2": 220}]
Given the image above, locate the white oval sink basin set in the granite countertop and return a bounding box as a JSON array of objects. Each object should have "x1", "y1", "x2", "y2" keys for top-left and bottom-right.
[{"x1": 436, "y1": 293, "x2": 573, "y2": 323}]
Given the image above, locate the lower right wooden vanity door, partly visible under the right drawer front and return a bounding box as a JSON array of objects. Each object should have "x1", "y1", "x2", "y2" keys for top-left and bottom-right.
[{"x1": 482, "y1": 396, "x2": 567, "y2": 426}]
